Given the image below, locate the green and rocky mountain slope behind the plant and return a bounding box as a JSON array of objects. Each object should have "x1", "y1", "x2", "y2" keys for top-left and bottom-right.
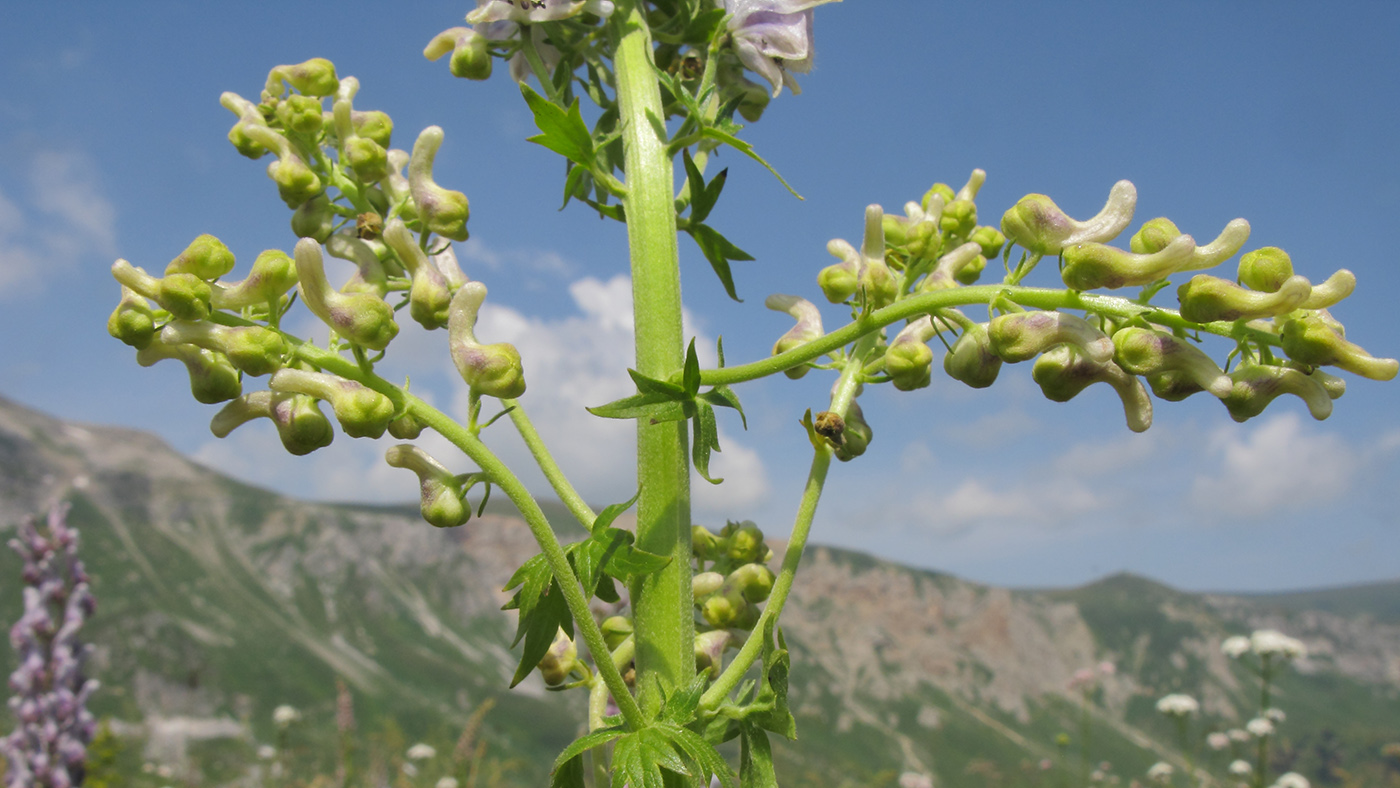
[{"x1": 0, "y1": 400, "x2": 1400, "y2": 785}]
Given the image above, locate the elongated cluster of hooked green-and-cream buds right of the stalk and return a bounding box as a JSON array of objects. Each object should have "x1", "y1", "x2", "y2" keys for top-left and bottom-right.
[{"x1": 769, "y1": 169, "x2": 1400, "y2": 436}]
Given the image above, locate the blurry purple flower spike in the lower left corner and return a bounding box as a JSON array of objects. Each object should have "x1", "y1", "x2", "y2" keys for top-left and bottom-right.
[{"x1": 0, "y1": 504, "x2": 98, "y2": 788}]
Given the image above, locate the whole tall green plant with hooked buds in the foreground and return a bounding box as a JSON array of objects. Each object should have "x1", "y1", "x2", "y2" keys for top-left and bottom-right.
[{"x1": 98, "y1": 0, "x2": 1397, "y2": 788}]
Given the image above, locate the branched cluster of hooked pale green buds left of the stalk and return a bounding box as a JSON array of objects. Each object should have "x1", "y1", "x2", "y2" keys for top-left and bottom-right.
[{"x1": 108, "y1": 59, "x2": 525, "y2": 498}]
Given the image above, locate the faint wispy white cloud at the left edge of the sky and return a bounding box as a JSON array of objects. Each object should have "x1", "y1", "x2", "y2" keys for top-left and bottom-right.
[{"x1": 0, "y1": 150, "x2": 116, "y2": 297}]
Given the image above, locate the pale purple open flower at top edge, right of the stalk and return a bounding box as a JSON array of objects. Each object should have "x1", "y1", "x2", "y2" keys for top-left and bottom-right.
[{"x1": 724, "y1": 0, "x2": 839, "y2": 97}]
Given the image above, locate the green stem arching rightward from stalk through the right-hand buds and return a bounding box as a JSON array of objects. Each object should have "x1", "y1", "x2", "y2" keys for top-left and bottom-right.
[{"x1": 694, "y1": 284, "x2": 1280, "y2": 386}]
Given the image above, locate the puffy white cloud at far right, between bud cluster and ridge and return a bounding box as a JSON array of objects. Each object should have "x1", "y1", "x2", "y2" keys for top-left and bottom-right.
[{"x1": 1191, "y1": 413, "x2": 1360, "y2": 518}]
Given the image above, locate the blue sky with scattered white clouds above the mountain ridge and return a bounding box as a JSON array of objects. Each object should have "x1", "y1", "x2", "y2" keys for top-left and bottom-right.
[{"x1": 0, "y1": 0, "x2": 1400, "y2": 589}]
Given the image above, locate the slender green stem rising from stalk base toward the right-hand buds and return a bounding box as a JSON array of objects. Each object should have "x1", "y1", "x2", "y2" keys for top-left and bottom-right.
[{"x1": 700, "y1": 335, "x2": 875, "y2": 711}]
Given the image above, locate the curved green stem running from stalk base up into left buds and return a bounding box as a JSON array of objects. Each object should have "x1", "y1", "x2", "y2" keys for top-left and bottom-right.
[{"x1": 280, "y1": 337, "x2": 645, "y2": 729}]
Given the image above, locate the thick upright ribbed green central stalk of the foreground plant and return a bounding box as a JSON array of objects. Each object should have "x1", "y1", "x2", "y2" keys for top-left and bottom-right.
[{"x1": 612, "y1": 1, "x2": 694, "y2": 712}]
